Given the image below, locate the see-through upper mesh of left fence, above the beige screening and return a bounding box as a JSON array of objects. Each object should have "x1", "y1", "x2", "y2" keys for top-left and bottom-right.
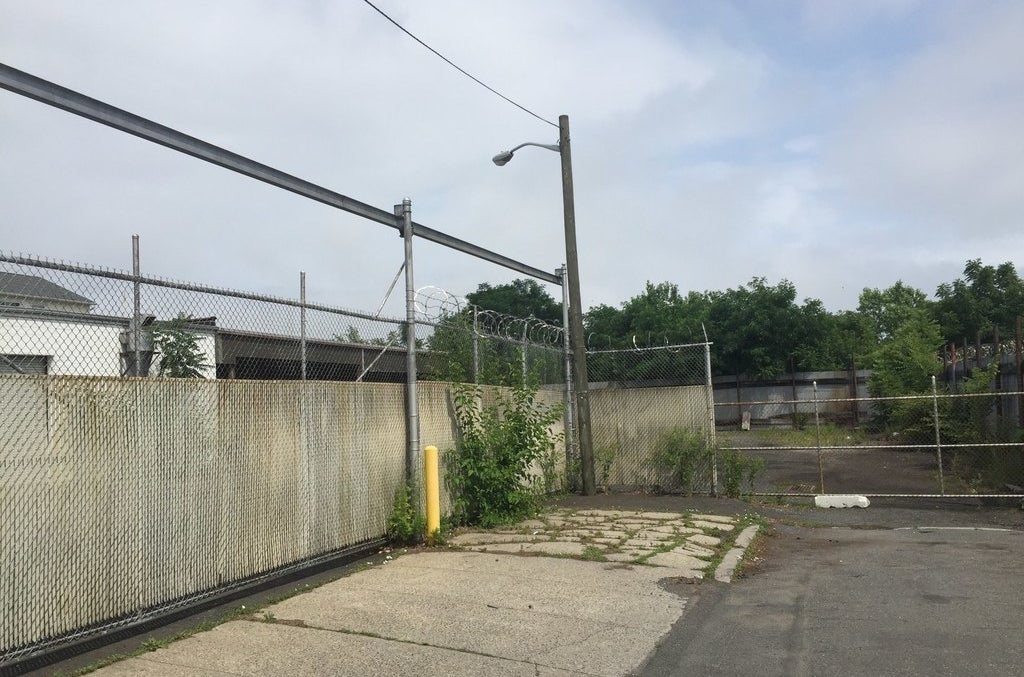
[{"x1": 0, "y1": 256, "x2": 406, "y2": 383}]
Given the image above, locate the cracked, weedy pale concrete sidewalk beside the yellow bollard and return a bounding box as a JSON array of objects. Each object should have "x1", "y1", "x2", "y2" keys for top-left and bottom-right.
[{"x1": 83, "y1": 511, "x2": 749, "y2": 677}]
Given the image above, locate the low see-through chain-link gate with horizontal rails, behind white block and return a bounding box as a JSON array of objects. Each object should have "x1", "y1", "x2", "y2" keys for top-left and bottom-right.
[{"x1": 715, "y1": 366, "x2": 1024, "y2": 497}]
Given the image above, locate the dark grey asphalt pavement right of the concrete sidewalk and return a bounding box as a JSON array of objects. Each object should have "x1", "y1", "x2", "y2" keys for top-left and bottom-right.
[{"x1": 638, "y1": 525, "x2": 1024, "y2": 677}]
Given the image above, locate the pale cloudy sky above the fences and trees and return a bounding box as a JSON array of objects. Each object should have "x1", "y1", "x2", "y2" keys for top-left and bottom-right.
[{"x1": 0, "y1": 0, "x2": 1024, "y2": 315}]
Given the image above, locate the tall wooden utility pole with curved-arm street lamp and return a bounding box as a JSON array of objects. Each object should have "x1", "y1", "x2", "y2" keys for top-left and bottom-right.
[{"x1": 493, "y1": 115, "x2": 597, "y2": 496}]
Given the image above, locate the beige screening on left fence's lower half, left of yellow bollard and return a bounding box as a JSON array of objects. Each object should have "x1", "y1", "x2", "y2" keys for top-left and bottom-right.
[{"x1": 0, "y1": 376, "x2": 404, "y2": 659}]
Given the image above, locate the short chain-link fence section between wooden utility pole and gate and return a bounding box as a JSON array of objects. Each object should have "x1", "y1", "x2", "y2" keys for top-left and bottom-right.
[{"x1": 587, "y1": 343, "x2": 717, "y2": 493}]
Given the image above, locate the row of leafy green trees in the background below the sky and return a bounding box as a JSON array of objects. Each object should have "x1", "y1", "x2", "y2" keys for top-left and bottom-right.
[{"x1": 458, "y1": 259, "x2": 1024, "y2": 378}]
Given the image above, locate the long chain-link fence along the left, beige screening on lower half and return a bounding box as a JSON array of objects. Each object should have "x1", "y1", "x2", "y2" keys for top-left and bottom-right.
[{"x1": 0, "y1": 249, "x2": 564, "y2": 666}]
